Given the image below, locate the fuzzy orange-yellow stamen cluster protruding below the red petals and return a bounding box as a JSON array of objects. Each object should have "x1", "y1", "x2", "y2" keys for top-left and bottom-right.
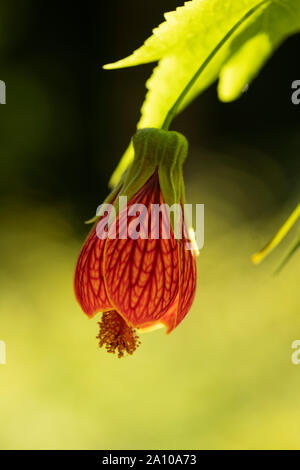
[{"x1": 97, "y1": 310, "x2": 141, "y2": 358}]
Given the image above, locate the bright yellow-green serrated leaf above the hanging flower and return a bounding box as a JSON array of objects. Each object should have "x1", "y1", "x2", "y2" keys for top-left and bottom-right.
[{"x1": 104, "y1": 0, "x2": 300, "y2": 185}]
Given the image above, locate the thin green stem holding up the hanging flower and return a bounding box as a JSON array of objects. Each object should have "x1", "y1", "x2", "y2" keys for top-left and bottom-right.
[{"x1": 162, "y1": 0, "x2": 270, "y2": 130}]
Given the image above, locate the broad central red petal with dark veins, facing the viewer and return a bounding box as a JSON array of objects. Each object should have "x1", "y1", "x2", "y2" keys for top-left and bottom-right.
[{"x1": 104, "y1": 174, "x2": 179, "y2": 326}]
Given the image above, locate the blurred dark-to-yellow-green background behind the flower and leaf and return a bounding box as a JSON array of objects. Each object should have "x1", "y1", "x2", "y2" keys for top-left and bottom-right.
[{"x1": 0, "y1": 0, "x2": 300, "y2": 449}]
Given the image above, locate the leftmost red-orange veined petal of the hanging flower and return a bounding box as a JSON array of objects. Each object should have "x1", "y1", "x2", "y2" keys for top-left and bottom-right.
[{"x1": 74, "y1": 225, "x2": 111, "y2": 317}]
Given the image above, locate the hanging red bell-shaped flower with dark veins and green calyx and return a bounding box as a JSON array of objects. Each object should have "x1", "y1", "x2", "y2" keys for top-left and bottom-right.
[{"x1": 74, "y1": 129, "x2": 196, "y2": 357}]
